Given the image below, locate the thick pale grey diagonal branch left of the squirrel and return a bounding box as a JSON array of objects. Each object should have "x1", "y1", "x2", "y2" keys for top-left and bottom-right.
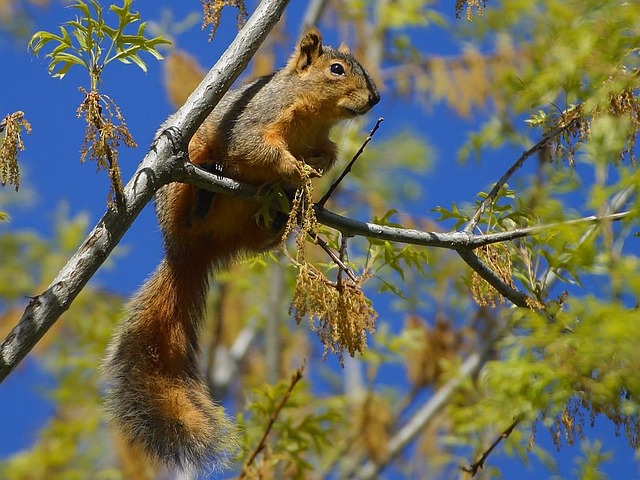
[{"x1": 0, "y1": 0, "x2": 288, "y2": 382}]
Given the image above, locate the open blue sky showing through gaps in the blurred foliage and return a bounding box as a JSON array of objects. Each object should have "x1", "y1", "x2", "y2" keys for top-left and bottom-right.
[{"x1": 0, "y1": 0, "x2": 640, "y2": 479}]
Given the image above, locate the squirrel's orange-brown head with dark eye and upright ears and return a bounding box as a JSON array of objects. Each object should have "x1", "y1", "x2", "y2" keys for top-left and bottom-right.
[{"x1": 285, "y1": 28, "x2": 380, "y2": 120}]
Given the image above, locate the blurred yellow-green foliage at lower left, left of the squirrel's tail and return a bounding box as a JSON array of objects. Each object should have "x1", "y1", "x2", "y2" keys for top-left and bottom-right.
[{"x1": 0, "y1": 211, "x2": 123, "y2": 480}]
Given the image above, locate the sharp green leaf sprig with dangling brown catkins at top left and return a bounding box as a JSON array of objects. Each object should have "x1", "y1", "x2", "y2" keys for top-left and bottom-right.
[{"x1": 29, "y1": 0, "x2": 170, "y2": 209}]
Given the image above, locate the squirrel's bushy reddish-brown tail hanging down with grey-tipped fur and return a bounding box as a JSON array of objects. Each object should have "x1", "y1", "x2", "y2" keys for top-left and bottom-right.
[{"x1": 103, "y1": 251, "x2": 237, "y2": 469}]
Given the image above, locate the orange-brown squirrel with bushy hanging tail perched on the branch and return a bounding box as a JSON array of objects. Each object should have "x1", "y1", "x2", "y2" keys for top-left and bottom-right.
[{"x1": 103, "y1": 28, "x2": 380, "y2": 476}]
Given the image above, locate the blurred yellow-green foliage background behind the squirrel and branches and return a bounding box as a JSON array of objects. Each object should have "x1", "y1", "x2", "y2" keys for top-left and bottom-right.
[{"x1": 0, "y1": 0, "x2": 640, "y2": 479}]
